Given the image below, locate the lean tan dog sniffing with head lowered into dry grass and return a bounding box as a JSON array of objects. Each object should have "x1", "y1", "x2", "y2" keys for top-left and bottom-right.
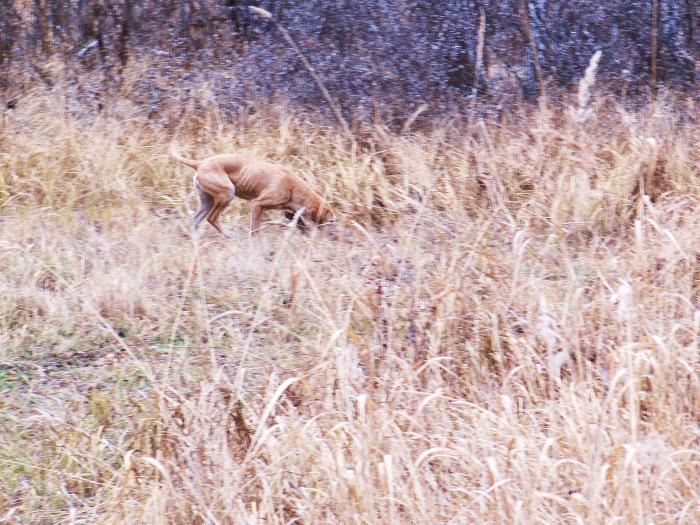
[{"x1": 170, "y1": 145, "x2": 335, "y2": 237}]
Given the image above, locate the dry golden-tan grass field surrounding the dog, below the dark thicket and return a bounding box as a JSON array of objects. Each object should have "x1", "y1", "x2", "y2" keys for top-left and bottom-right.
[{"x1": 0, "y1": 80, "x2": 700, "y2": 525}]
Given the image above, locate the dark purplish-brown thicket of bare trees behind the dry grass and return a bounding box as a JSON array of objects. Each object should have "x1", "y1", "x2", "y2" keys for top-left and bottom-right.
[{"x1": 0, "y1": 0, "x2": 700, "y2": 118}]
